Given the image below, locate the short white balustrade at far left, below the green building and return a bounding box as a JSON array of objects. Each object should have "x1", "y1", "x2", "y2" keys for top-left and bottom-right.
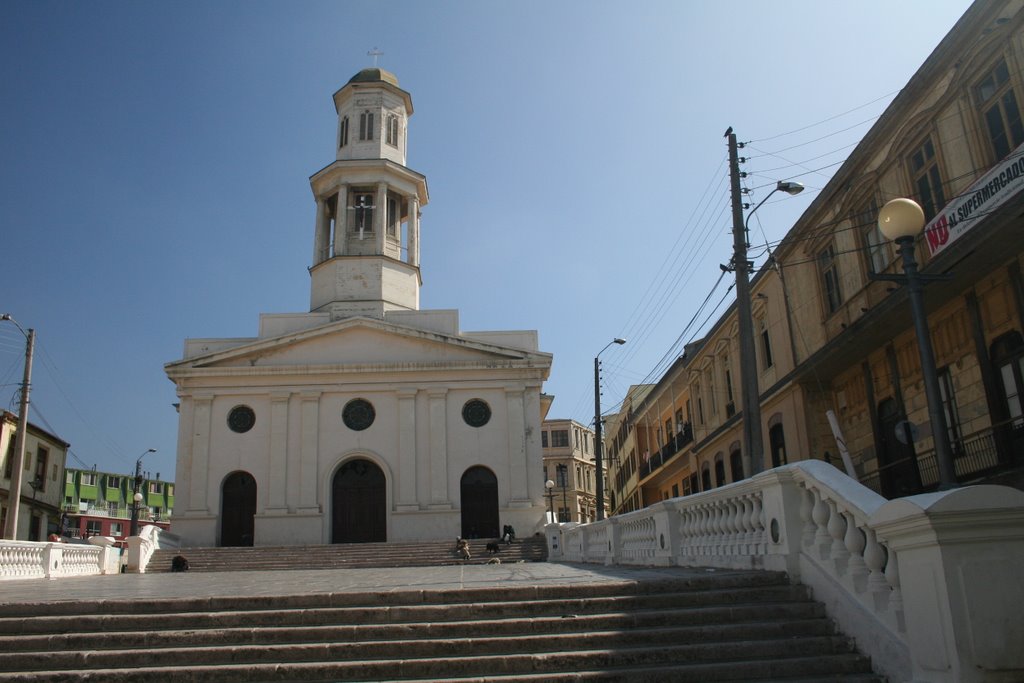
[{"x1": 0, "y1": 541, "x2": 121, "y2": 581}]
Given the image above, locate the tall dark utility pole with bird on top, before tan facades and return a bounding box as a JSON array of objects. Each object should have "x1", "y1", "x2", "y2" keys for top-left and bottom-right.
[{"x1": 725, "y1": 127, "x2": 764, "y2": 477}]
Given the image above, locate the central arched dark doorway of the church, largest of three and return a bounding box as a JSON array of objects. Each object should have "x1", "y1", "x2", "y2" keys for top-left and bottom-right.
[{"x1": 331, "y1": 458, "x2": 387, "y2": 543}]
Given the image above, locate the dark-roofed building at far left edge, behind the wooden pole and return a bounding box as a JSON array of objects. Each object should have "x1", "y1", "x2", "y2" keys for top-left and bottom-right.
[{"x1": 0, "y1": 411, "x2": 68, "y2": 541}]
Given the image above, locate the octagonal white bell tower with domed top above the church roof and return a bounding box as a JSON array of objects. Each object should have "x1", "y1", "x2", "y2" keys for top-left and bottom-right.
[{"x1": 309, "y1": 68, "x2": 428, "y2": 319}]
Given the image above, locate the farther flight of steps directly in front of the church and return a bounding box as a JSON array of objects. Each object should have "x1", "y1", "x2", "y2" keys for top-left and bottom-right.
[{"x1": 145, "y1": 537, "x2": 548, "y2": 573}]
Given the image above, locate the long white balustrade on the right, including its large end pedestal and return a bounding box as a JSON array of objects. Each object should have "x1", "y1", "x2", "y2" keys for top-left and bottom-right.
[{"x1": 546, "y1": 461, "x2": 1024, "y2": 683}]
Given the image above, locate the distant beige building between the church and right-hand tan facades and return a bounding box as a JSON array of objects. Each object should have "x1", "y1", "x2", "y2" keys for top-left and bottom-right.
[{"x1": 541, "y1": 420, "x2": 608, "y2": 522}]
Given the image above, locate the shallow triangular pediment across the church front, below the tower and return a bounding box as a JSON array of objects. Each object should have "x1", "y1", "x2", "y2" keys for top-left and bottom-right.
[{"x1": 167, "y1": 318, "x2": 551, "y2": 376}]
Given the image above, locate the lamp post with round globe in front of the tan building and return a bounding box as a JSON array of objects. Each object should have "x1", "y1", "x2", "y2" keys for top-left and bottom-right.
[{"x1": 879, "y1": 198, "x2": 957, "y2": 490}]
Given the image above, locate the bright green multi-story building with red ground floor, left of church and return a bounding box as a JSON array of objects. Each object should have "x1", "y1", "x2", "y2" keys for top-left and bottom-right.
[{"x1": 63, "y1": 468, "x2": 174, "y2": 541}]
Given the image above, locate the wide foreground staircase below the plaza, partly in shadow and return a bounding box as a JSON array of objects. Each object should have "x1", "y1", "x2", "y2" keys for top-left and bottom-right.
[{"x1": 0, "y1": 571, "x2": 883, "y2": 683}]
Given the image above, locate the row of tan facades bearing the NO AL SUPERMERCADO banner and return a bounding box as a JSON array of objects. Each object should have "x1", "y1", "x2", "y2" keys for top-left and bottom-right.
[{"x1": 610, "y1": 0, "x2": 1024, "y2": 510}]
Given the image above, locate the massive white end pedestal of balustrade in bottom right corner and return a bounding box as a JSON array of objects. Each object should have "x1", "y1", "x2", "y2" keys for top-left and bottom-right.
[{"x1": 870, "y1": 486, "x2": 1024, "y2": 683}]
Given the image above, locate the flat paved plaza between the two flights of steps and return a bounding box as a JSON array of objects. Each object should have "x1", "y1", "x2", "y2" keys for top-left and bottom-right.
[{"x1": 0, "y1": 562, "x2": 728, "y2": 604}]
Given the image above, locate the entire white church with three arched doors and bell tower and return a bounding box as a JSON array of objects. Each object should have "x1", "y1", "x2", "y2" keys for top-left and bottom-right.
[{"x1": 165, "y1": 69, "x2": 551, "y2": 546}]
